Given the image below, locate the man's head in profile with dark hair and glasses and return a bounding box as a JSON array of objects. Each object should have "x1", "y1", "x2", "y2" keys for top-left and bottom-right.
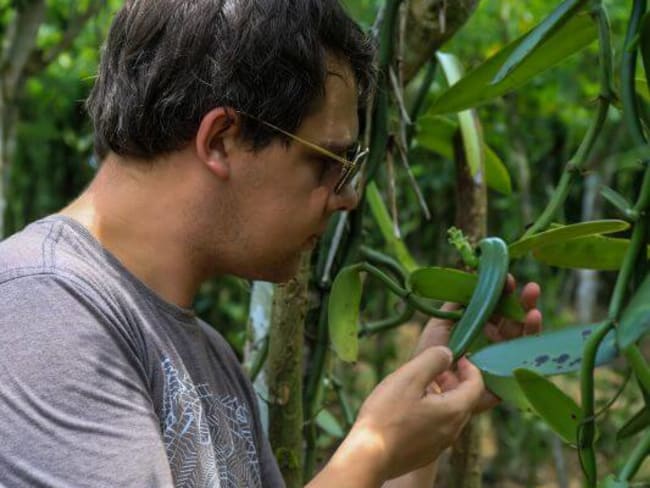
[{"x1": 83, "y1": 0, "x2": 373, "y2": 281}]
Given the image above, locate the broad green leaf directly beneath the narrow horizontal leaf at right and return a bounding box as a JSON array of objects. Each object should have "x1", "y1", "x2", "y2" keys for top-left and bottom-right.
[{"x1": 533, "y1": 235, "x2": 650, "y2": 270}]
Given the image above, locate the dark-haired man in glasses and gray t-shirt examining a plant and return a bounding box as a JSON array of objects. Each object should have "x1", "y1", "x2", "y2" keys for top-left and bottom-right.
[{"x1": 0, "y1": 0, "x2": 540, "y2": 488}]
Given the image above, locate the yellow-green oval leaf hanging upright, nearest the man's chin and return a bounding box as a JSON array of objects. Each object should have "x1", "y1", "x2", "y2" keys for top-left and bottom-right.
[{"x1": 327, "y1": 266, "x2": 362, "y2": 362}]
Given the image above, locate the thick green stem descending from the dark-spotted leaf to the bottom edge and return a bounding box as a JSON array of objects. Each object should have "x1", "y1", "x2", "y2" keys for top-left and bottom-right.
[{"x1": 578, "y1": 321, "x2": 614, "y2": 487}]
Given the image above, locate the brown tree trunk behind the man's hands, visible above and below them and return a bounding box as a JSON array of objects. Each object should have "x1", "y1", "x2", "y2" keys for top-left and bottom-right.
[{"x1": 436, "y1": 133, "x2": 487, "y2": 488}]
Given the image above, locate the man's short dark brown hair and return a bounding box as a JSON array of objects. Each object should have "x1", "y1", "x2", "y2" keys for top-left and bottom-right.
[{"x1": 88, "y1": 0, "x2": 372, "y2": 160}]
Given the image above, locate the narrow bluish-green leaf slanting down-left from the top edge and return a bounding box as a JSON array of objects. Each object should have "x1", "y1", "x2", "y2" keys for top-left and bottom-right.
[{"x1": 491, "y1": 0, "x2": 585, "y2": 85}]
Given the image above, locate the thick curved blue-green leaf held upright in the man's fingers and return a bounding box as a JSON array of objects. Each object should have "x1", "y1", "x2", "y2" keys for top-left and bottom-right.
[{"x1": 449, "y1": 237, "x2": 508, "y2": 360}]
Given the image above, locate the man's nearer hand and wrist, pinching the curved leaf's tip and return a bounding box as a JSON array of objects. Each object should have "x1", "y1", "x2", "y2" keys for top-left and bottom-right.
[{"x1": 309, "y1": 346, "x2": 484, "y2": 488}]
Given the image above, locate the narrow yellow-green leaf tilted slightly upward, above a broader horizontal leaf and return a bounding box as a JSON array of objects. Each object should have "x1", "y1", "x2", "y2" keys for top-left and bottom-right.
[{"x1": 508, "y1": 220, "x2": 630, "y2": 258}]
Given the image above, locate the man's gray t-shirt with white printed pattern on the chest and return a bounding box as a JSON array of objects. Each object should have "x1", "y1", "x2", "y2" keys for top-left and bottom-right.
[{"x1": 0, "y1": 216, "x2": 284, "y2": 488}]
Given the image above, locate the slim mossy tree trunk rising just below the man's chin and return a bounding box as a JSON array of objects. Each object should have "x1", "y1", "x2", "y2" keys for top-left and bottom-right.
[{"x1": 266, "y1": 253, "x2": 310, "y2": 488}]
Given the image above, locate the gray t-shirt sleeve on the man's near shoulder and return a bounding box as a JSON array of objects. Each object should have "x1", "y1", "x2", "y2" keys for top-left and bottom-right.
[{"x1": 0, "y1": 274, "x2": 173, "y2": 488}]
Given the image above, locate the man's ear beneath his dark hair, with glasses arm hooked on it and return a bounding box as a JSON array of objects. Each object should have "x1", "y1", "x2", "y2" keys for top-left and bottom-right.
[{"x1": 195, "y1": 107, "x2": 239, "y2": 180}]
